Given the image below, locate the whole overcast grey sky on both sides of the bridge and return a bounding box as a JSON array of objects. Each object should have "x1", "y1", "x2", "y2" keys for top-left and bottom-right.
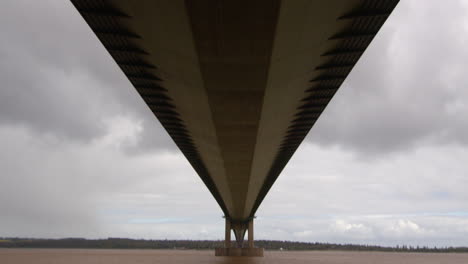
[{"x1": 0, "y1": 0, "x2": 468, "y2": 246}]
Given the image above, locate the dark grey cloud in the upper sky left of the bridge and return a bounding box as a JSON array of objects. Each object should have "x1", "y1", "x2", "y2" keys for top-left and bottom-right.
[{"x1": 0, "y1": 1, "x2": 175, "y2": 153}]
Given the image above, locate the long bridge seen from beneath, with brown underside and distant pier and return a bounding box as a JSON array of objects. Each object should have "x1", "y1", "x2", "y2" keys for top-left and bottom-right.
[{"x1": 72, "y1": 0, "x2": 398, "y2": 255}]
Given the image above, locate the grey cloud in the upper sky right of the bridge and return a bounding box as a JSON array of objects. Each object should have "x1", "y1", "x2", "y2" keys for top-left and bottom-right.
[{"x1": 308, "y1": 1, "x2": 468, "y2": 154}]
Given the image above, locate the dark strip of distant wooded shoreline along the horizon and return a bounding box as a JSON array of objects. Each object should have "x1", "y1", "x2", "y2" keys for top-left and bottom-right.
[{"x1": 0, "y1": 237, "x2": 468, "y2": 253}]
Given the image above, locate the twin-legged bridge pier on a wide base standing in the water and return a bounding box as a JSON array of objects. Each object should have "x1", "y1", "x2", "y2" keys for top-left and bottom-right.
[{"x1": 215, "y1": 217, "x2": 263, "y2": 257}]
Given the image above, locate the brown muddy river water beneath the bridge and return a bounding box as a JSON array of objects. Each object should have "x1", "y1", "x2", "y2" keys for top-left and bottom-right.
[{"x1": 0, "y1": 249, "x2": 468, "y2": 264}]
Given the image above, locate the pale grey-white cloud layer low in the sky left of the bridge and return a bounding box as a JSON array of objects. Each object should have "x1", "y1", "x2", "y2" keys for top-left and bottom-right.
[{"x1": 0, "y1": 121, "x2": 223, "y2": 238}]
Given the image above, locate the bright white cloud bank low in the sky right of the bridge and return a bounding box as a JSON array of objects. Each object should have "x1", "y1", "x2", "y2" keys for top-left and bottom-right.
[{"x1": 256, "y1": 143, "x2": 468, "y2": 246}]
